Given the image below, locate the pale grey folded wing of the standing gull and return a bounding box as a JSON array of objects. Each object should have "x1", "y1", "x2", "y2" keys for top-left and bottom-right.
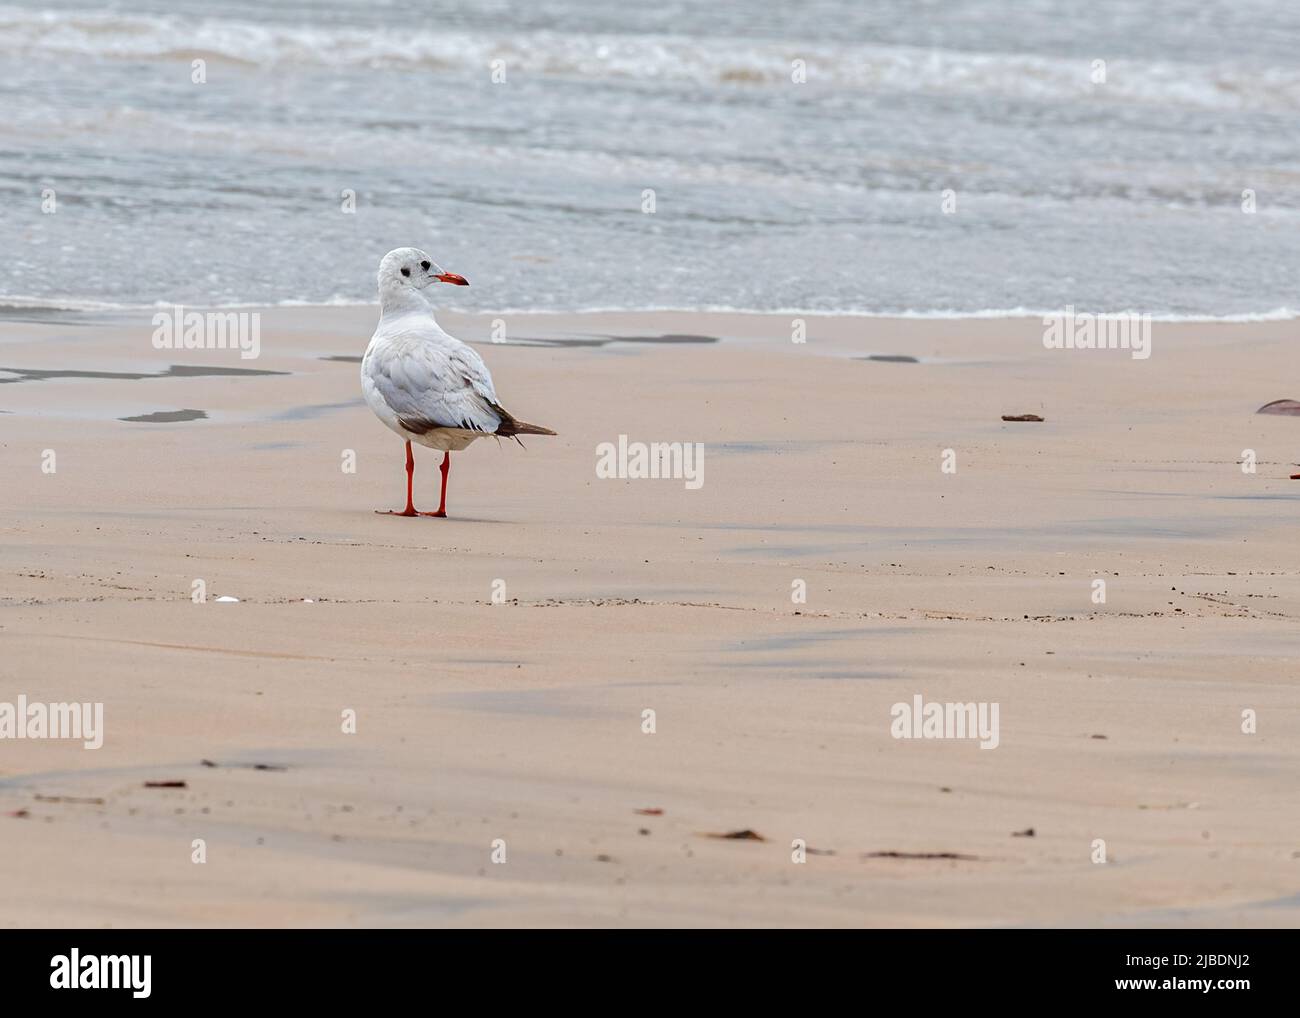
[{"x1": 372, "y1": 330, "x2": 502, "y2": 434}]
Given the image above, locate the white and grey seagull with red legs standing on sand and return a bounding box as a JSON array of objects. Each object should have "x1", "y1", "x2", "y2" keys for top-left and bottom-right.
[{"x1": 361, "y1": 247, "x2": 555, "y2": 517}]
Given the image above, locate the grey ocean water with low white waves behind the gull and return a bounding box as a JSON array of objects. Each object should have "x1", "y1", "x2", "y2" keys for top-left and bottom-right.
[{"x1": 0, "y1": 0, "x2": 1300, "y2": 317}]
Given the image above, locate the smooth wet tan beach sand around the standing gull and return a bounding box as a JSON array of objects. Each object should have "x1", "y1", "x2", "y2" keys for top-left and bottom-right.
[{"x1": 0, "y1": 308, "x2": 1300, "y2": 926}]
